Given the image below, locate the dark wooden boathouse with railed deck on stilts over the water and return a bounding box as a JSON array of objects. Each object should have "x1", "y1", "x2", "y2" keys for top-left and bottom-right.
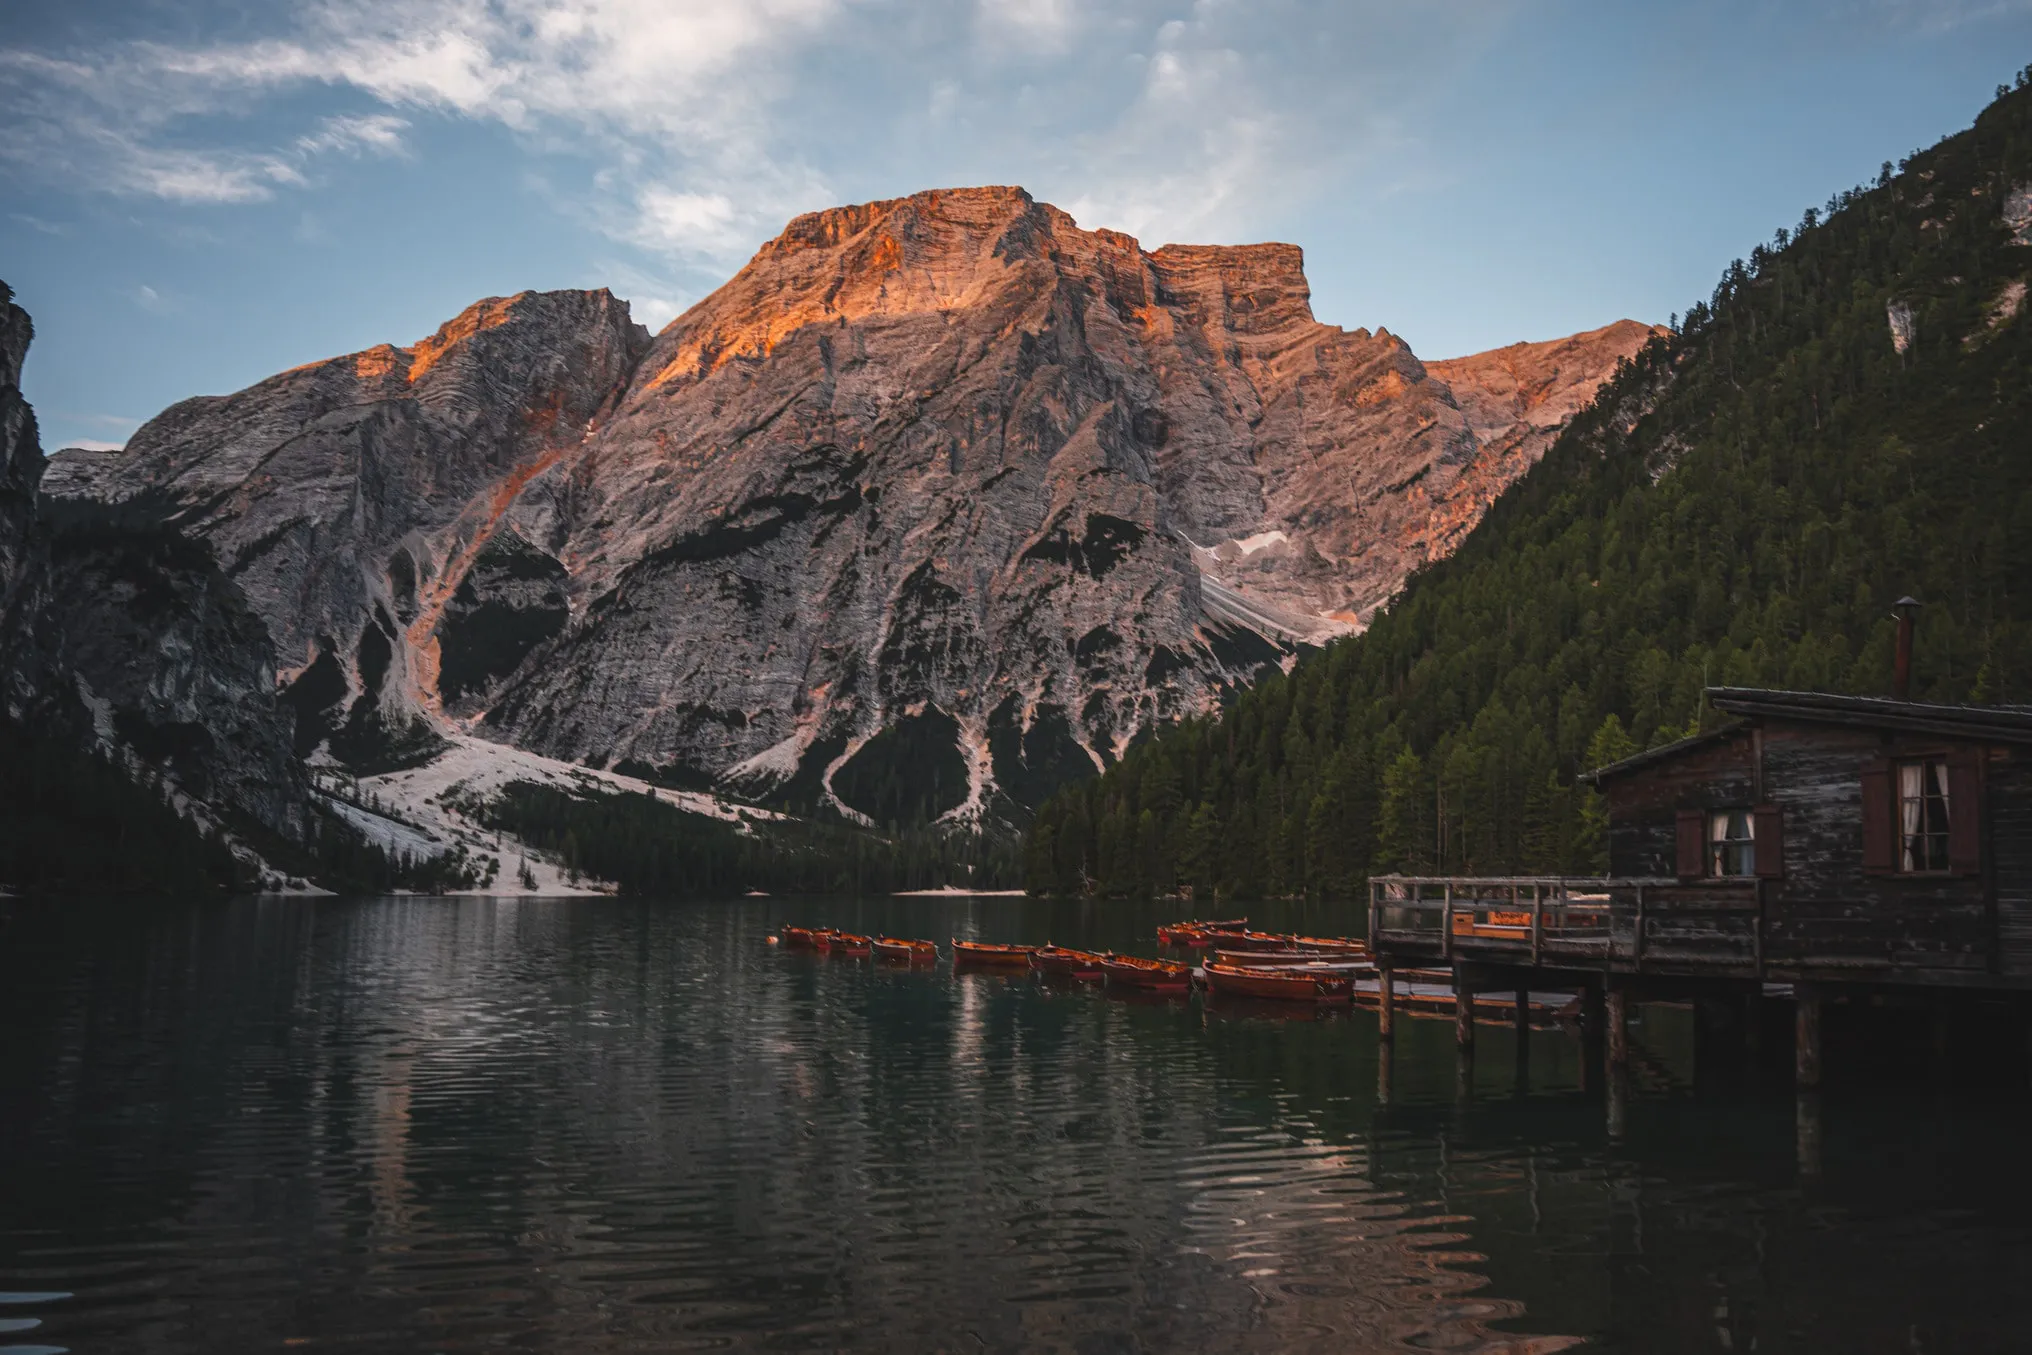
[{"x1": 1370, "y1": 687, "x2": 2032, "y2": 1087}]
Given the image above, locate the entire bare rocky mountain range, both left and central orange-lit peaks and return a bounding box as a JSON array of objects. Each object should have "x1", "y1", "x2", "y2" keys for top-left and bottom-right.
[{"x1": 43, "y1": 189, "x2": 1650, "y2": 841}]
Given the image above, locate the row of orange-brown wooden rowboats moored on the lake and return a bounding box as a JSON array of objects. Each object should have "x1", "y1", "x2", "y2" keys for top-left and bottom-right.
[{"x1": 770, "y1": 918, "x2": 1376, "y2": 1002}]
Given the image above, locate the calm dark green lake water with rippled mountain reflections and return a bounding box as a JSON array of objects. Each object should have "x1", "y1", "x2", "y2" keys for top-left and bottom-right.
[{"x1": 0, "y1": 898, "x2": 2032, "y2": 1355}]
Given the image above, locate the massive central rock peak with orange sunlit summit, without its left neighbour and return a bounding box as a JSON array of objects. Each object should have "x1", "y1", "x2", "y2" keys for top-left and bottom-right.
[{"x1": 488, "y1": 189, "x2": 1648, "y2": 819}]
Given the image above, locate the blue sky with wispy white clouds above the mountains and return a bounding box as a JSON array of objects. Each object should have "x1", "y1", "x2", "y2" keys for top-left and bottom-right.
[{"x1": 0, "y1": 0, "x2": 2032, "y2": 449}]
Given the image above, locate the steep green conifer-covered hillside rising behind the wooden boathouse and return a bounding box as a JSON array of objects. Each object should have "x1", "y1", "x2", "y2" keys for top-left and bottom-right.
[{"x1": 1026, "y1": 75, "x2": 2032, "y2": 898}]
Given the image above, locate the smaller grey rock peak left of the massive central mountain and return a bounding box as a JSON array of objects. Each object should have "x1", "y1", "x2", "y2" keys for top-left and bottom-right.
[{"x1": 43, "y1": 291, "x2": 648, "y2": 768}]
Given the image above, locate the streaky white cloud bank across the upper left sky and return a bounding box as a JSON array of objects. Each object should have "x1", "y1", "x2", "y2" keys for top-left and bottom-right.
[{"x1": 0, "y1": 0, "x2": 841, "y2": 260}]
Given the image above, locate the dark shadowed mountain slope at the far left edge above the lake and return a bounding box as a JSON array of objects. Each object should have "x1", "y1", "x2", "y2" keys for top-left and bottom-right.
[{"x1": 0, "y1": 284, "x2": 305, "y2": 894}]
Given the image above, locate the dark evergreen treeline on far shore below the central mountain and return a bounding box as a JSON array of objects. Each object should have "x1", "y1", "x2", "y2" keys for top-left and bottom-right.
[{"x1": 465, "y1": 782, "x2": 1022, "y2": 898}]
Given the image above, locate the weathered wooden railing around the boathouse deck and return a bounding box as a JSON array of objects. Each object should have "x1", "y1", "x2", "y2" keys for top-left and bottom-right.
[{"x1": 1370, "y1": 876, "x2": 1762, "y2": 969}]
